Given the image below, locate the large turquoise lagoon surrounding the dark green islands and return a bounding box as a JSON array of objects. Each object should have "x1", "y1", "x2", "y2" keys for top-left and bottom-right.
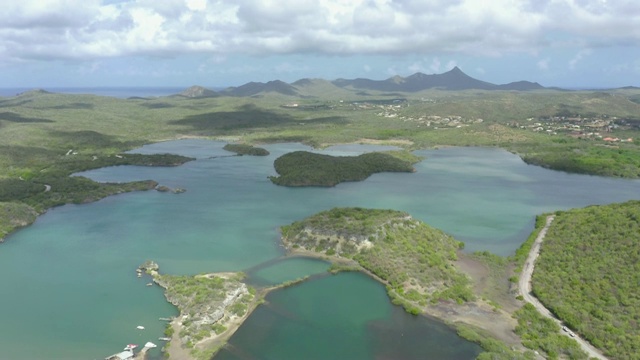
[{"x1": 0, "y1": 140, "x2": 640, "y2": 359}]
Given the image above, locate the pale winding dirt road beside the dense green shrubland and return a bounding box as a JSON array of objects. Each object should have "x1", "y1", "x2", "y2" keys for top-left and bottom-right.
[{"x1": 518, "y1": 215, "x2": 608, "y2": 360}]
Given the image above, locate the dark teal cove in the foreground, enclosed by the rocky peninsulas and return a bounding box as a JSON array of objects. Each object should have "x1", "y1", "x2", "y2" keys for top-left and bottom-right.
[{"x1": 215, "y1": 273, "x2": 480, "y2": 360}]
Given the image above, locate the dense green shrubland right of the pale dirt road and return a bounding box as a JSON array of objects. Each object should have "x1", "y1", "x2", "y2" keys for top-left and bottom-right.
[{"x1": 532, "y1": 201, "x2": 640, "y2": 359}]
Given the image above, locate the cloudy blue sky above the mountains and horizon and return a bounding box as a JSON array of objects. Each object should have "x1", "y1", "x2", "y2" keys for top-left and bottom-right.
[{"x1": 0, "y1": 0, "x2": 640, "y2": 88}]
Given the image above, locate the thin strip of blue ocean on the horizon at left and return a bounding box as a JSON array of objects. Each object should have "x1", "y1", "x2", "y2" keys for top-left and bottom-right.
[{"x1": 0, "y1": 86, "x2": 224, "y2": 99}]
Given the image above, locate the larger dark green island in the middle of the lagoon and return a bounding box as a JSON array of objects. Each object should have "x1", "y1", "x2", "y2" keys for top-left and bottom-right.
[{"x1": 269, "y1": 151, "x2": 421, "y2": 186}]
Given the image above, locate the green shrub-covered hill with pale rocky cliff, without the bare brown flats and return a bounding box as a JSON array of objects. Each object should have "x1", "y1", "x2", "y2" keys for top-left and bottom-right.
[{"x1": 282, "y1": 208, "x2": 474, "y2": 314}]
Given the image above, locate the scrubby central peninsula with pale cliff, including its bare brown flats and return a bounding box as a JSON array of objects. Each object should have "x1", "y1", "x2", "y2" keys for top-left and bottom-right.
[{"x1": 281, "y1": 208, "x2": 535, "y2": 359}]
